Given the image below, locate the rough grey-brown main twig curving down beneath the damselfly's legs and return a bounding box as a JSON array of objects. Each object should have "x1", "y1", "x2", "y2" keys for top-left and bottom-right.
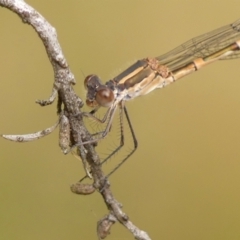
[{"x1": 0, "y1": 0, "x2": 150, "y2": 240}]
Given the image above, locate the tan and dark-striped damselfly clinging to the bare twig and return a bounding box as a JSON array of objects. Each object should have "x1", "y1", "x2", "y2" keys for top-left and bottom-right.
[{"x1": 78, "y1": 19, "x2": 240, "y2": 176}]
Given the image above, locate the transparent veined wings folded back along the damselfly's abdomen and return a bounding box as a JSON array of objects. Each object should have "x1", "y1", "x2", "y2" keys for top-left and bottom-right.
[{"x1": 157, "y1": 19, "x2": 240, "y2": 71}]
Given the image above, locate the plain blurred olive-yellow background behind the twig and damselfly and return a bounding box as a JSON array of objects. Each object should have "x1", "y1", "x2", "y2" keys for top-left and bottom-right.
[{"x1": 0, "y1": 0, "x2": 240, "y2": 240}]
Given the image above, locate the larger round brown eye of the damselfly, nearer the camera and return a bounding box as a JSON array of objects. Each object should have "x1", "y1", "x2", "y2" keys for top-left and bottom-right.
[{"x1": 96, "y1": 87, "x2": 114, "y2": 107}]
